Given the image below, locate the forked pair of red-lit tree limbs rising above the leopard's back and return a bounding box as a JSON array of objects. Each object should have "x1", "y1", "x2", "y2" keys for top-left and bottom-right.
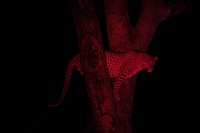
[{"x1": 104, "y1": 0, "x2": 193, "y2": 52}]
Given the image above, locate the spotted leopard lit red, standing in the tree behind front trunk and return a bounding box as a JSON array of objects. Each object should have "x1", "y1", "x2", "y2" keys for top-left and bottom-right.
[{"x1": 49, "y1": 51, "x2": 157, "y2": 107}]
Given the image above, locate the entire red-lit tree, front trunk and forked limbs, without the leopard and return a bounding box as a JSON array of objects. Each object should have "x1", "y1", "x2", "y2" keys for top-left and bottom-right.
[{"x1": 71, "y1": 0, "x2": 192, "y2": 133}]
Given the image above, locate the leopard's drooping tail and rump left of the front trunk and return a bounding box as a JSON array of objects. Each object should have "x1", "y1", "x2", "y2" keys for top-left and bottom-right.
[{"x1": 49, "y1": 55, "x2": 82, "y2": 107}]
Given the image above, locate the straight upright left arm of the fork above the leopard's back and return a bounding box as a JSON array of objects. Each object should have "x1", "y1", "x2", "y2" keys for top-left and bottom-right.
[{"x1": 104, "y1": 0, "x2": 133, "y2": 52}]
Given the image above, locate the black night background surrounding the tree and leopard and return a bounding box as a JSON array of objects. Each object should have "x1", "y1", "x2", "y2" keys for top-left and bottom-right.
[{"x1": 4, "y1": 0, "x2": 199, "y2": 133}]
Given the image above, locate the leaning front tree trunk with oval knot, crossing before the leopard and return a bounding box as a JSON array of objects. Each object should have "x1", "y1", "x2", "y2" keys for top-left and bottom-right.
[{"x1": 71, "y1": 0, "x2": 124, "y2": 133}]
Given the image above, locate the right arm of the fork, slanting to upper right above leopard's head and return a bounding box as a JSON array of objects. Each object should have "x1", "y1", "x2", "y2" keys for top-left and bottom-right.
[{"x1": 132, "y1": 0, "x2": 192, "y2": 52}]
